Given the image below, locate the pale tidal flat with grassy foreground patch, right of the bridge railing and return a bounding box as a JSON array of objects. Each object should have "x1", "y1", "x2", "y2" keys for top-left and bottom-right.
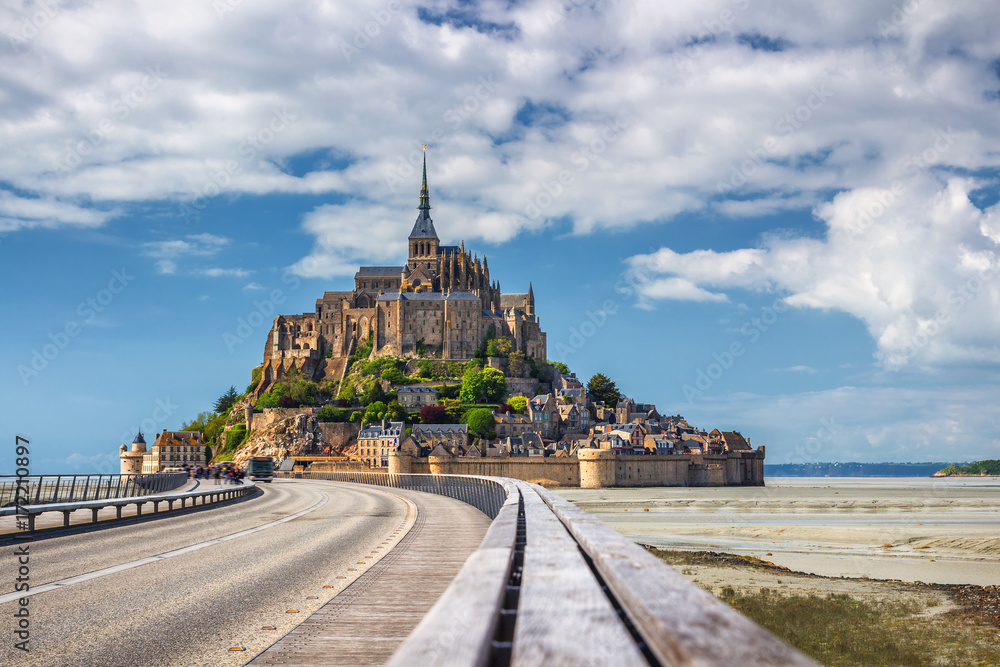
[{"x1": 556, "y1": 477, "x2": 1000, "y2": 665}]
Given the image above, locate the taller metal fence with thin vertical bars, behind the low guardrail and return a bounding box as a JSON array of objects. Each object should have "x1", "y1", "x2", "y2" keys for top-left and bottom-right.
[{"x1": 0, "y1": 472, "x2": 188, "y2": 507}]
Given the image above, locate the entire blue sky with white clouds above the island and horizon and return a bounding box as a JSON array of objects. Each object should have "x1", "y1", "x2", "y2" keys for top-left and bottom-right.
[{"x1": 0, "y1": 0, "x2": 1000, "y2": 472}]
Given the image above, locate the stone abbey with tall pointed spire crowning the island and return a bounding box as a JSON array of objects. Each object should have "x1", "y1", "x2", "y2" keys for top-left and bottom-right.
[{"x1": 263, "y1": 153, "x2": 546, "y2": 384}]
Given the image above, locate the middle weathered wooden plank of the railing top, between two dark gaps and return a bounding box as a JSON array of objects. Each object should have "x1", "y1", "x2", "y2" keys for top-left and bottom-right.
[{"x1": 511, "y1": 483, "x2": 648, "y2": 667}]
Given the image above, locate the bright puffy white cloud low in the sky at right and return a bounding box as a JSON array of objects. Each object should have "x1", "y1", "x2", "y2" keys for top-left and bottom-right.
[{"x1": 630, "y1": 175, "x2": 1000, "y2": 368}]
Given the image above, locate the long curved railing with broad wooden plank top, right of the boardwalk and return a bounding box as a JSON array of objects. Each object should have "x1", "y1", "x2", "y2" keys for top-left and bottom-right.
[{"x1": 281, "y1": 473, "x2": 814, "y2": 667}]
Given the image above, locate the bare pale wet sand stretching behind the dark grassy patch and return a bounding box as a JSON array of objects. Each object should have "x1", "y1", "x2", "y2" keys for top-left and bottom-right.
[{"x1": 554, "y1": 477, "x2": 1000, "y2": 586}]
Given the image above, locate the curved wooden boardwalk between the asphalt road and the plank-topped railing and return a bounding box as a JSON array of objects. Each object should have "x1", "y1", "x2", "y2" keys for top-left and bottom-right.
[{"x1": 246, "y1": 487, "x2": 490, "y2": 665}]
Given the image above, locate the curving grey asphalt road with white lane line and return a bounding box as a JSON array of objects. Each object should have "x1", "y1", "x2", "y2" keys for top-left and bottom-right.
[{"x1": 0, "y1": 480, "x2": 407, "y2": 667}]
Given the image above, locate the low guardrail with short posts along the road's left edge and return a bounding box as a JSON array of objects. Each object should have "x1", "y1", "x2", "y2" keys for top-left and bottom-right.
[{"x1": 0, "y1": 480, "x2": 257, "y2": 531}]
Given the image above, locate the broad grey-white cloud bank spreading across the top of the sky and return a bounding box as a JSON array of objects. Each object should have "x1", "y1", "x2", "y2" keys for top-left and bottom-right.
[{"x1": 0, "y1": 0, "x2": 1000, "y2": 245}]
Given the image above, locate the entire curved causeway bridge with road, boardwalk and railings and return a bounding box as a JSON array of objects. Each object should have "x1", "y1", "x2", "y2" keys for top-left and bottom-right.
[{"x1": 0, "y1": 472, "x2": 813, "y2": 667}]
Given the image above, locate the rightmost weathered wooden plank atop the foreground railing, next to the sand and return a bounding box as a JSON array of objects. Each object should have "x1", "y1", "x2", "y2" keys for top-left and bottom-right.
[{"x1": 528, "y1": 485, "x2": 815, "y2": 665}]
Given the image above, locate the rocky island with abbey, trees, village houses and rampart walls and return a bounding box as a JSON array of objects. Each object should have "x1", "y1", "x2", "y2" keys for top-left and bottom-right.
[{"x1": 139, "y1": 156, "x2": 764, "y2": 487}]
